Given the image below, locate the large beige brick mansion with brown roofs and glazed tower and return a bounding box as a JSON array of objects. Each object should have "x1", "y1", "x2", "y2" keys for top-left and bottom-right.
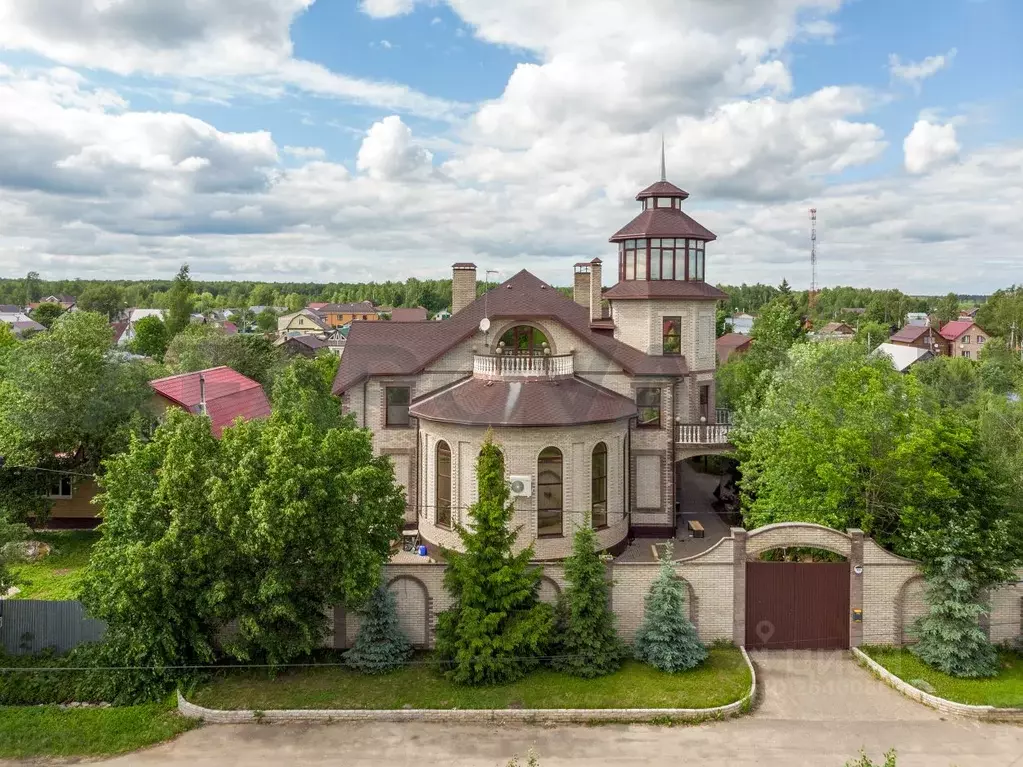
[{"x1": 333, "y1": 167, "x2": 731, "y2": 559}]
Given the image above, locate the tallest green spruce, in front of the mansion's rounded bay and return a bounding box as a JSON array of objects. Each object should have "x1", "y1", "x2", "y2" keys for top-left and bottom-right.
[{"x1": 436, "y1": 435, "x2": 553, "y2": 684}]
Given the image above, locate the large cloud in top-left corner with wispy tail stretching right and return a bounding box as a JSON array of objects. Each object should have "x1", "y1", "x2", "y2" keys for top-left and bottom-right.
[{"x1": 0, "y1": 0, "x2": 461, "y2": 118}]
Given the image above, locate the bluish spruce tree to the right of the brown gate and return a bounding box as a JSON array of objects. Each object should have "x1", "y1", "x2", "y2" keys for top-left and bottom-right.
[{"x1": 909, "y1": 555, "x2": 998, "y2": 678}]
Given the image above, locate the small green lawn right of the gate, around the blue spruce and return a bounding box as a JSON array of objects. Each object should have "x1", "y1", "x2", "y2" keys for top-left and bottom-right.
[{"x1": 860, "y1": 647, "x2": 1023, "y2": 709}]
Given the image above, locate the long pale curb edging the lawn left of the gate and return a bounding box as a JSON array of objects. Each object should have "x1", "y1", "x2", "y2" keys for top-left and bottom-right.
[{"x1": 178, "y1": 647, "x2": 757, "y2": 724}]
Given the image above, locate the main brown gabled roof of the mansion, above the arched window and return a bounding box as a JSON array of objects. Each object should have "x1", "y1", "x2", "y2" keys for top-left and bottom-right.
[{"x1": 333, "y1": 270, "x2": 688, "y2": 394}]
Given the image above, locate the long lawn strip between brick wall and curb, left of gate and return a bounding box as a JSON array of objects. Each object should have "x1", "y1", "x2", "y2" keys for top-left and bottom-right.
[{"x1": 191, "y1": 647, "x2": 750, "y2": 711}]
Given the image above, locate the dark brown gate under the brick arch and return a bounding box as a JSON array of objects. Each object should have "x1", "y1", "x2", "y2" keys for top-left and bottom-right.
[{"x1": 746, "y1": 561, "x2": 849, "y2": 649}]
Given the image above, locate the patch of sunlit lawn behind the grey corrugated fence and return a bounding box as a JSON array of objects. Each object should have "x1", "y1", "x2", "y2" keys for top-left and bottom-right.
[{"x1": 11, "y1": 530, "x2": 99, "y2": 599}]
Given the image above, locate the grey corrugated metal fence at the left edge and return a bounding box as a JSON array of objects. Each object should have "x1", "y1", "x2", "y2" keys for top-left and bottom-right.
[{"x1": 0, "y1": 599, "x2": 106, "y2": 655}]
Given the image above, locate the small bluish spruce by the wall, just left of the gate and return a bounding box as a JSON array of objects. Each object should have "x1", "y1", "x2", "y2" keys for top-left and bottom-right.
[{"x1": 633, "y1": 543, "x2": 707, "y2": 674}]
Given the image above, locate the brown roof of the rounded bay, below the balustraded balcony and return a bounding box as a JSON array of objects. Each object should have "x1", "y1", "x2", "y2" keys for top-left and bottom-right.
[{"x1": 409, "y1": 376, "x2": 636, "y2": 426}]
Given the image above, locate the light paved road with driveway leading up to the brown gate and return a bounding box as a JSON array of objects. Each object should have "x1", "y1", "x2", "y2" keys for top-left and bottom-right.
[{"x1": 7, "y1": 652, "x2": 1023, "y2": 767}]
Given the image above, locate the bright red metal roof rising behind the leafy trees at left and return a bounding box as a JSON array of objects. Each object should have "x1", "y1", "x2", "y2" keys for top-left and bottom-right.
[{"x1": 149, "y1": 367, "x2": 270, "y2": 437}]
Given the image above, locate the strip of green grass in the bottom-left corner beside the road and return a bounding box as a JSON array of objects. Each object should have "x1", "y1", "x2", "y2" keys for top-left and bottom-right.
[{"x1": 0, "y1": 704, "x2": 197, "y2": 759}]
